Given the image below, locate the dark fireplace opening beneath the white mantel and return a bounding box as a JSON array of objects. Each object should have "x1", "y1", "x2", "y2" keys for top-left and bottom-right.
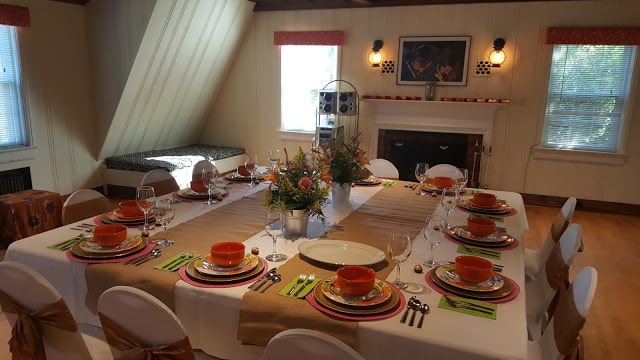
[{"x1": 377, "y1": 129, "x2": 482, "y2": 186}]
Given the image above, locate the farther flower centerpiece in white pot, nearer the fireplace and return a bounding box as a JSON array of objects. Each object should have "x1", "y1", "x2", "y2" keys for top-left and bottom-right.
[{"x1": 314, "y1": 130, "x2": 371, "y2": 203}]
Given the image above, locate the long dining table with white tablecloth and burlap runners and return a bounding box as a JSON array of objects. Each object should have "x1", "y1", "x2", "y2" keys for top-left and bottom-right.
[{"x1": 5, "y1": 181, "x2": 528, "y2": 359}]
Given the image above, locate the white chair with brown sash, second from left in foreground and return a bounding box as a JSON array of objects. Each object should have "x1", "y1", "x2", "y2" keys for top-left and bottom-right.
[{"x1": 98, "y1": 286, "x2": 195, "y2": 359}]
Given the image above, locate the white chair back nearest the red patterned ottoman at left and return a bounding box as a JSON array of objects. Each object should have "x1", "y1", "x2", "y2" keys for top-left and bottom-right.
[{"x1": 62, "y1": 189, "x2": 115, "y2": 225}]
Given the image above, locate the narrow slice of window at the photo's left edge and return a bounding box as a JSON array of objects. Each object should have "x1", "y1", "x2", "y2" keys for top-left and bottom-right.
[{"x1": 0, "y1": 25, "x2": 31, "y2": 150}]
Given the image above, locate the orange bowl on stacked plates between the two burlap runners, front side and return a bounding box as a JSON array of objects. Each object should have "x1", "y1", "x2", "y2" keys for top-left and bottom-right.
[{"x1": 178, "y1": 241, "x2": 267, "y2": 287}]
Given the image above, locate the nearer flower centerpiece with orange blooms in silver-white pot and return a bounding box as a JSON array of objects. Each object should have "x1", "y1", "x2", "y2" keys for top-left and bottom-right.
[{"x1": 262, "y1": 147, "x2": 329, "y2": 235}]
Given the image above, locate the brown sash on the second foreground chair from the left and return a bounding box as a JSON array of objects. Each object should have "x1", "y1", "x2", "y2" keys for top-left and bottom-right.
[{"x1": 98, "y1": 312, "x2": 195, "y2": 360}]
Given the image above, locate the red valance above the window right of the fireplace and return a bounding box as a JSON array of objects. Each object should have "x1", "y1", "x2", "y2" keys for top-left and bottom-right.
[{"x1": 545, "y1": 26, "x2": 640, "y2": 45}]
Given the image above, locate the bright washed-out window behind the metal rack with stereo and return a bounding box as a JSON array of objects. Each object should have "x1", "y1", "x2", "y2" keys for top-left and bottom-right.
[{"x1": 280, "y1": 45, "x2": 338, "y2": 131}]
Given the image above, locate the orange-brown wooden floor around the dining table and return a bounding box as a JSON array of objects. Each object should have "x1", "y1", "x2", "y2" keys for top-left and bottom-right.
[{"x1": 0, "y1": 205, "x2": 640, "y2": 360}]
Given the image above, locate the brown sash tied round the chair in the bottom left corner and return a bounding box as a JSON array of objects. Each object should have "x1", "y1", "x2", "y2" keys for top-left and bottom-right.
[{"x1": 0, "y1": 290, "x2": 78, "y2": 360}]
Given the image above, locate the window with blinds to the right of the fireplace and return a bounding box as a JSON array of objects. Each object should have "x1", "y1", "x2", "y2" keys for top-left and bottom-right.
[{"x1": 542, "y1": 45, "x2": 636, "y2": 153}]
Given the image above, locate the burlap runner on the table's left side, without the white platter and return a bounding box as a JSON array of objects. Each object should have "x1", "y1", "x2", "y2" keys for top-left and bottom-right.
[{"x1": 85, "y1": 191, "x2": 266, "y2": 313}]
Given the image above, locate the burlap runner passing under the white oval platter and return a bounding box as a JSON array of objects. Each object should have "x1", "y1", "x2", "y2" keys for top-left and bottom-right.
[{"x1": 238, "y1": 182, "x2": 438, "y2": 348}]
